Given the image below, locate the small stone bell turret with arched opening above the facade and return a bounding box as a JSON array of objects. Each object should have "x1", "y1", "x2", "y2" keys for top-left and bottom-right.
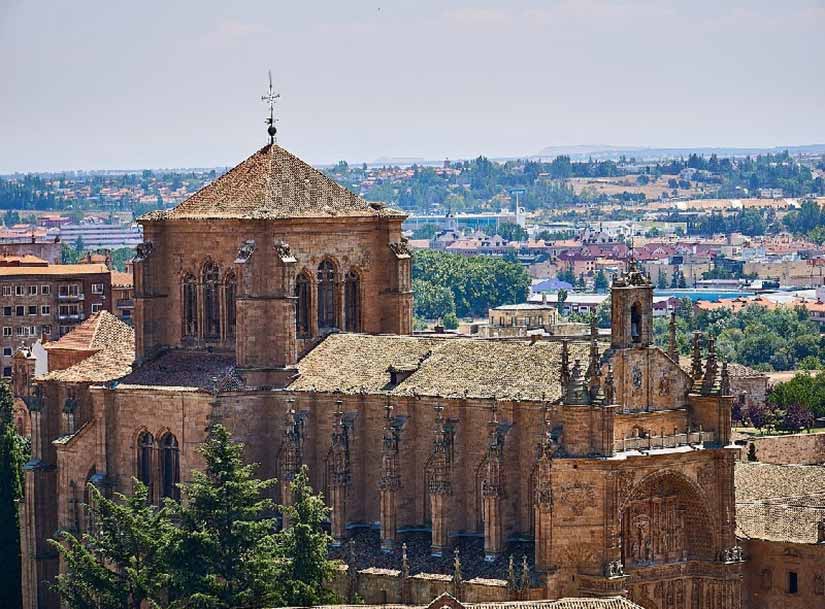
[{"x1": 610, "y1": 260, "x2": 653, "y2": 349}]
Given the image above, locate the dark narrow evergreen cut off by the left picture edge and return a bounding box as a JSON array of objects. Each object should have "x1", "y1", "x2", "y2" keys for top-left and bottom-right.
[{"x1": 0, "y1": 381, "x2": 23, "y2": 607}]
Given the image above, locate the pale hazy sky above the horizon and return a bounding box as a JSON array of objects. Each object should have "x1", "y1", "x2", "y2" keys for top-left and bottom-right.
[{"x1": 0, "y1": 0, "x2": 825, "y2": 173}]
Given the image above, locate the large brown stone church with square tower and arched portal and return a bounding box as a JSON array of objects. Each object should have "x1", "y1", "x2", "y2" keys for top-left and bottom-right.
[{"x1": 15, "y1": 144, "x2": 742, "y2": 609}]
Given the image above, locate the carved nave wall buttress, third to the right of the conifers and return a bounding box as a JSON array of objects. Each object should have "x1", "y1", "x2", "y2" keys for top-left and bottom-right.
[{"x1": 427, "y1": 406, "x2": 452, "y2": 556}]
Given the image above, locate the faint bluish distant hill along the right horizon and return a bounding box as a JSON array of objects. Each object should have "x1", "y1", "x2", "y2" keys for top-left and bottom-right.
[{"x1": 530, "y1": 144, "x2": 825, "y2": 160}]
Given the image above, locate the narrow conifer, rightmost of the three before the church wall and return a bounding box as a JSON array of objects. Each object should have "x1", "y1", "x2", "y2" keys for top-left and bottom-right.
[{"x1": 277, "y1": 466, "x2": 336, "y2": 607}]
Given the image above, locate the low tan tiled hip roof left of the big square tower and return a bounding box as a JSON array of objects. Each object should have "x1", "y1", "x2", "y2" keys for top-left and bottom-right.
[{"x1": 37, "y1": 311, "x2": 135, "y2": 383}]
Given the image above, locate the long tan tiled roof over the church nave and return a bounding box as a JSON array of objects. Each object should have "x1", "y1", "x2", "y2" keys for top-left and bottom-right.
[{"x1": 288, "y1": 334, "x2": 588, "y2": 401}]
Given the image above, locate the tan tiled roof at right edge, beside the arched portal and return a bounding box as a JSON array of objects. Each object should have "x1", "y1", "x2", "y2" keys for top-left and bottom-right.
[{"x1": 735, "y1": 463, "x2": 825, "y2": 543}]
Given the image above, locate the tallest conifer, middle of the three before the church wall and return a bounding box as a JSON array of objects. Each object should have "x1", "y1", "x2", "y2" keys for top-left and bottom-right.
[{"x1": 168, "y1": 425, "x2": 281, "y2": 609}]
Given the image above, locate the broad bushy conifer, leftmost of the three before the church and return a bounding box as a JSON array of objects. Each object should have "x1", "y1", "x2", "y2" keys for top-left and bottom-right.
[{"x1": 52, "y1": 480, "x2": 170, "y2": 609}]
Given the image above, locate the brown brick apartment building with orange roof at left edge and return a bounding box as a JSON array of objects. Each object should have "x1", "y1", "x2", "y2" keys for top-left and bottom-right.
[{"x1": 0, "y1": 256, "x2": 112, "y2": 377}]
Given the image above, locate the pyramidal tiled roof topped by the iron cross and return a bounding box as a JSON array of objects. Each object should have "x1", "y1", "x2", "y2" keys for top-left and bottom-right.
[{"x1": 146, "y1": 144, "x2": 403, "y2": 221}]
